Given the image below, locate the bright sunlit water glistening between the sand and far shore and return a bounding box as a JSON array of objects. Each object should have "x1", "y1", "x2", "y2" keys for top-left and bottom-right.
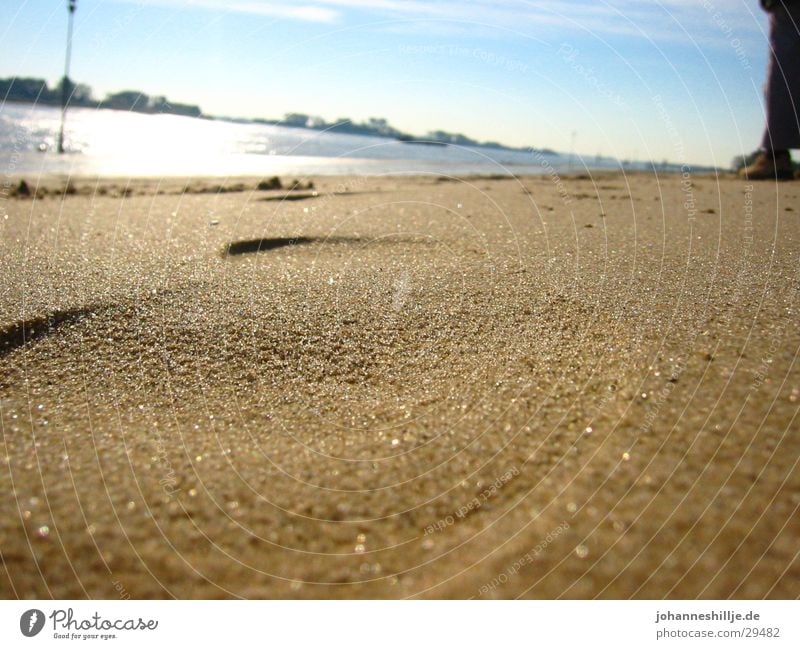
[{"x1": 0, "y1": 103, "x2": 618, "y2": 177}]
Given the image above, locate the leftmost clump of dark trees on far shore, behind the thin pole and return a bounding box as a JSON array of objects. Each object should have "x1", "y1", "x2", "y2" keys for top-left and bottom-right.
[{"x1": 0, "y1": 77, "x2": 202, "y2": 117}]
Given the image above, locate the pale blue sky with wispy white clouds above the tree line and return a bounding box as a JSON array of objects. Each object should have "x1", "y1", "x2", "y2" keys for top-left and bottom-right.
[{"x1": 0, "y1": 0, "x2": 767, "y2": 167}]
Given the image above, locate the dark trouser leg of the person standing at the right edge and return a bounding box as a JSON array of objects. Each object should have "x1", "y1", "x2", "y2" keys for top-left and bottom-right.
[{"x1": 761, "y1": 5, "x2": 800, "y2": 151}]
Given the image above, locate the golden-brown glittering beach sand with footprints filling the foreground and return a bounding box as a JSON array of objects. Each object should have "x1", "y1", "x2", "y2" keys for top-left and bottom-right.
[{"x1": 0, "y1": 173, "x2": 800, "y2": 599}]
